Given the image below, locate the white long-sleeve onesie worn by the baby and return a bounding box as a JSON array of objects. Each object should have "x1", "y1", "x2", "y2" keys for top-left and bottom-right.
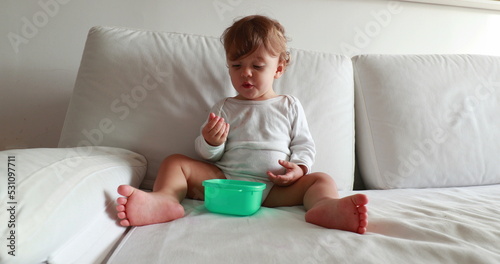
[{"x1": 195, "y1": 95, "x2": 316, "y2": 182}]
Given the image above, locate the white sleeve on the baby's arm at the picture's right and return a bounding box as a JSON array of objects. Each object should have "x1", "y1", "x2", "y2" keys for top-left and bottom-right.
[{"x1": 290, "y1": 98, "x2": 316, "y2": 173}]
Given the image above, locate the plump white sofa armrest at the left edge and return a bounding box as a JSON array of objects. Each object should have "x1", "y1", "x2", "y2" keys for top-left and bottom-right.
[{"x1": 0, "y1": 147, "x2": 146, "y2": 263}]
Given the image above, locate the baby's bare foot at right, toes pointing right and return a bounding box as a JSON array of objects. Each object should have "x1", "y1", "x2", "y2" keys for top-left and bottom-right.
[{"x1": 306, "y1": 194, "x2": 368, "y2": 234}]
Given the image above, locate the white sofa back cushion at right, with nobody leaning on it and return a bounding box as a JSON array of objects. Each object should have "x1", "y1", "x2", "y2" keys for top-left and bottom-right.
[{"x1": 353, "y1": 55, "x2": 500, "y2": 189}]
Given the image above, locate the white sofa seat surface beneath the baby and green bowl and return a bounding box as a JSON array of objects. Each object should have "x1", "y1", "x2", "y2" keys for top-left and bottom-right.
[{"x1": 108, "y1": 185, "x2": 500, "y2": 264}]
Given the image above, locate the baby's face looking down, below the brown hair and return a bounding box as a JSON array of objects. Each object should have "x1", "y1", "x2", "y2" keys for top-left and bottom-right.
[{"x1": 227, "y1": 46, "x2": 284, "y2": 100}]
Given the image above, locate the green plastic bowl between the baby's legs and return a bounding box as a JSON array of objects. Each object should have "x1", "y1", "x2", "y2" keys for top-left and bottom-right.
[{"x1": 203, "y1": 179, "x2": 266, "y2": 216}]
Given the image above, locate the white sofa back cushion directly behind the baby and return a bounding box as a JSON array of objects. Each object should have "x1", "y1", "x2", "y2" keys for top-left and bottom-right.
[{"x1": 59, "y1": 27, "x2": 354, "y2": 190}]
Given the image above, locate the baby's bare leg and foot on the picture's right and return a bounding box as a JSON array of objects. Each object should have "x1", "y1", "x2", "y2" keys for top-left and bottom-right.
[{"x1": 264, "y1": 173, "x2": 368, "y2": 234}]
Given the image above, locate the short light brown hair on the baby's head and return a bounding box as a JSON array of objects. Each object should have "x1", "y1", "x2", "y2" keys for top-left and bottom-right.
[{"x1": 221, "y1": 15, "x2": 290, "y2": 66}]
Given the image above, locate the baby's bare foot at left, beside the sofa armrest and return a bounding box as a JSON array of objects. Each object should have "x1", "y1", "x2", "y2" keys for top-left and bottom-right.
[{"x1": 116, "y1": 185, "x2": 184, "y2": 226}]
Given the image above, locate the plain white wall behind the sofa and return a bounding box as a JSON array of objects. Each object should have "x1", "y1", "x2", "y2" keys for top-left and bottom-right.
[{"x1": 0, "y1": 0, "x2": 500, "y2": 150}]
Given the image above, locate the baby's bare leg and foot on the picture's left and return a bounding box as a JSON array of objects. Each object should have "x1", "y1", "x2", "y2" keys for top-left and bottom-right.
[{"x1": 116, "y1": 155, "x2": 224, "y2": 226}]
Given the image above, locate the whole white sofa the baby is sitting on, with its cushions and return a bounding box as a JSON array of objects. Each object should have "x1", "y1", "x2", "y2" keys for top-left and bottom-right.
[{"x1": 0, "y1": 27, "x2": 500, "y2": 263}]
